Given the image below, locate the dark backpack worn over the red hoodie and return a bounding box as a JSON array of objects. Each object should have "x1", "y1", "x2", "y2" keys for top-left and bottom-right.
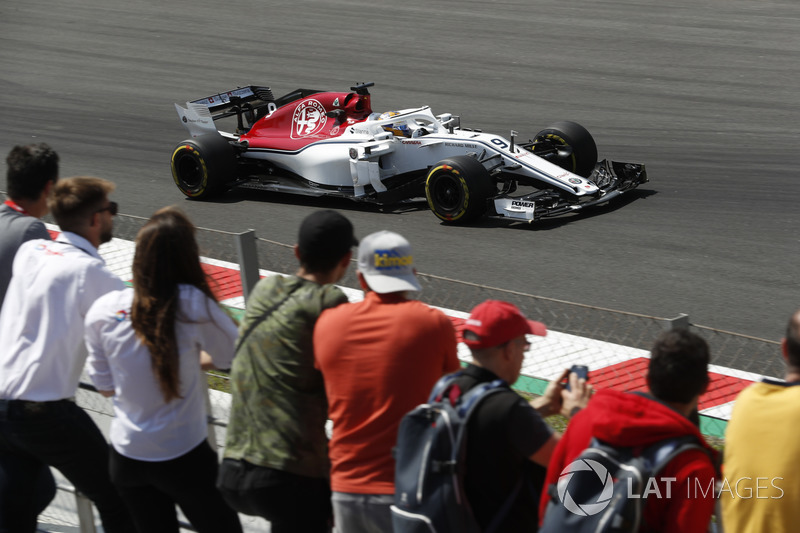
[{"x1": 539, "y1": 435, "x2": 707, "y2": 533}]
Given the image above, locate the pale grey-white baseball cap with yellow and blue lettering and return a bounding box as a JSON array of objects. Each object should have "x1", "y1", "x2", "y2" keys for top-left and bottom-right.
[{"x1": 358, "y1": 231, "x2": 422, "y2": 294}]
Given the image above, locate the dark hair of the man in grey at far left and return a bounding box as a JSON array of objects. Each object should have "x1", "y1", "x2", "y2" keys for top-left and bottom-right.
[{"x1": 6, "y1": 143, "x2": 58, "y2": 200}]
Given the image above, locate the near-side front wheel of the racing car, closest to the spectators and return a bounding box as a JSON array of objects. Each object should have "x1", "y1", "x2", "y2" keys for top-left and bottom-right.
[{"x1": 425, "y1": 155, "x2": 495, "y2": 224}]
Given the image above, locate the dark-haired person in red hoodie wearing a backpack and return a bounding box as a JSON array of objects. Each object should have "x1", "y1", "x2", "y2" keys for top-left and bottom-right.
[{"x1": 539, "y1": 330, "x2": 717, "y2": 533}]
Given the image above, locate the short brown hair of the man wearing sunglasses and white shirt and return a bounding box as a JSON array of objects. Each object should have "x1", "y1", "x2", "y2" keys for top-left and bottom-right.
[{"x1": 48, "y1": 176, "x2": 115, "y2": 232}]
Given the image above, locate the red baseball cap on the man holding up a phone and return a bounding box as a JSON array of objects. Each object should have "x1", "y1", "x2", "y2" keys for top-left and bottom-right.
[{"x1": 462, "y1": 300, "x2": 547, "y2": 350}]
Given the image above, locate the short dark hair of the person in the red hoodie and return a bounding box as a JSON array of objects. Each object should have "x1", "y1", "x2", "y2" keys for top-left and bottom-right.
[{"x1": 647, "y1": 329, "x2": 711, "y2": 403}]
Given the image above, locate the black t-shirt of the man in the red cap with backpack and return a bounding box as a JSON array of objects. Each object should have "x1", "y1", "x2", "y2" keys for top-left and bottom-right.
[{"x1": 455, "y1": 365, "x2": 552, "y2": 532}]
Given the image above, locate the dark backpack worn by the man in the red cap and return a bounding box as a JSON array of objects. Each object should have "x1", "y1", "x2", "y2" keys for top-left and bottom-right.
[{"x1": 392, "y1": 373, "x2": 522, "y2": 533}]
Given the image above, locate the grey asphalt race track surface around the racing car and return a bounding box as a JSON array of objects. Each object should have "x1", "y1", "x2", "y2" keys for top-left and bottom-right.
[{"x1": 0, "y1": 0, "x2": 800, "y2": 350}]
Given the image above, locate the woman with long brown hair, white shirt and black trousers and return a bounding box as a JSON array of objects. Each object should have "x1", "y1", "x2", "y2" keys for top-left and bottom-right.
[{"x1": 86, "y1": 207, "x2": 242, "y2": 533}]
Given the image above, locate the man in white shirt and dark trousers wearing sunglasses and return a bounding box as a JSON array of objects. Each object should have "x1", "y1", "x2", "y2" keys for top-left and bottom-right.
[{"x1": 0, "y1": 177, "x2": 133, "y2": 533}]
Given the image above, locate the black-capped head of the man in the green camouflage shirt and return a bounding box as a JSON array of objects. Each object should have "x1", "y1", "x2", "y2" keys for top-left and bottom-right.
[{"x1": 297, "y1": 209, "x2": 358, "y2": 274}]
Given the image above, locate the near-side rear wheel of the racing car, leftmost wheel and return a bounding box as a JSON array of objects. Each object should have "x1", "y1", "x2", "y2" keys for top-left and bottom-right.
[{"x1": 171, "y1": 134, "x2": 236, "y2": 199}]
